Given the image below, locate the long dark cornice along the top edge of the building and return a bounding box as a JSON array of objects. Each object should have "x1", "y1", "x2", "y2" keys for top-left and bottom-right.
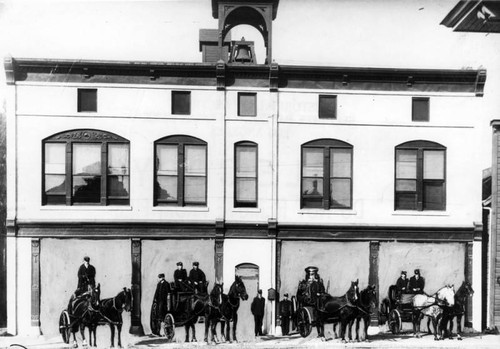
[{"x1": 5, "y1": 58, "x2": 486, "y2": 96}]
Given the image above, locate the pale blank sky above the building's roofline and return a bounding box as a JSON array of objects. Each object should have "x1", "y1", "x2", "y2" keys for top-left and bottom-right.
[{"x1": 0, "y1": 0, "x2": 500, "y2": 162}]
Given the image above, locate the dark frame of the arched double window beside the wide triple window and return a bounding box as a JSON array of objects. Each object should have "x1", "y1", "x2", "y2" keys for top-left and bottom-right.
[{"x1": 153, "y1": 135, "x2": 208, "y2": 207}]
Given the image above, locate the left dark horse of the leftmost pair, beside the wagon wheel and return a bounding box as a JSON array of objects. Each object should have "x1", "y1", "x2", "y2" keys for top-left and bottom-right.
[{"x1": 68, "y1": 284, "x2": 101, "y2": 348}]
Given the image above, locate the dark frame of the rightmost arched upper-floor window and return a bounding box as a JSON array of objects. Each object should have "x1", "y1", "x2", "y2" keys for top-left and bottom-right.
[{"x1": 394, "y1": 140, "x2": 447, "y2": 212}]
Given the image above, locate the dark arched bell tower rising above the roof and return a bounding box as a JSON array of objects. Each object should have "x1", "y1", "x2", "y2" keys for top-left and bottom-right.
[{"x1": 212, "y1": 0, "x2": 279, "y2": 64}]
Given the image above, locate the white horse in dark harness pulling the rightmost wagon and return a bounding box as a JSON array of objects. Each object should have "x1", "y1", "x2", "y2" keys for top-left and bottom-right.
[{"x1": 413, "y1": 285, "x2": 455, "y2": 340}]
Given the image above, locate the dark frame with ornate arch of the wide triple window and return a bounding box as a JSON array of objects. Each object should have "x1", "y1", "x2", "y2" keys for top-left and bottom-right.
[{"x1": 41, "y1": 129, "x2": 131, "y2": 206}]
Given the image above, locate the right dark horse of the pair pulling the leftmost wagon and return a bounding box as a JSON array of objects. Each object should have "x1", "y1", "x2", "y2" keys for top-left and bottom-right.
[{"x1": 89, "y1": 287, "x2": 132, "y2": 348}]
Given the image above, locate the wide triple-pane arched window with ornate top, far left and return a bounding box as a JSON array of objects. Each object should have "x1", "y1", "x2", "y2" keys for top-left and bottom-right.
[{"x1": 42, "y1": 130, "x2": 130, "y2": 205}]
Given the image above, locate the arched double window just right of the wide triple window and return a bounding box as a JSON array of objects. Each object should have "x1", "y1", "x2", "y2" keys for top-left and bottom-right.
[{"x1": 154, "y1": 135, "x2": 207, "y2": 206}]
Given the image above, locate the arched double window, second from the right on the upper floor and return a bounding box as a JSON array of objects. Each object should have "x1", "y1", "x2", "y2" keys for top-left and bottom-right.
[{"x1": 300, "y1": 139, "x2": 352, "y2": 210}]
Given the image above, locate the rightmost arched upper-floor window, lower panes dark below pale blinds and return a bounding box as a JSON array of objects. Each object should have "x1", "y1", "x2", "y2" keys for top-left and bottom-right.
[{"x1": 394, "y1": 140, "x2": 446, "y2": 211}]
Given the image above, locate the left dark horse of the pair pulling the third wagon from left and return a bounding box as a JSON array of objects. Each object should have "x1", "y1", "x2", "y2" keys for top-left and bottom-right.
[{"x1": 316, "y1": 280, "x2": 359, "y2": 343}]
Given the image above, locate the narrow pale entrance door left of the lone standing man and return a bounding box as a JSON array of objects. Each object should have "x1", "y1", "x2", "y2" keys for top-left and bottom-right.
[{"x1": 235, "y1": 263, "x2": 259, "y2": 342}]
